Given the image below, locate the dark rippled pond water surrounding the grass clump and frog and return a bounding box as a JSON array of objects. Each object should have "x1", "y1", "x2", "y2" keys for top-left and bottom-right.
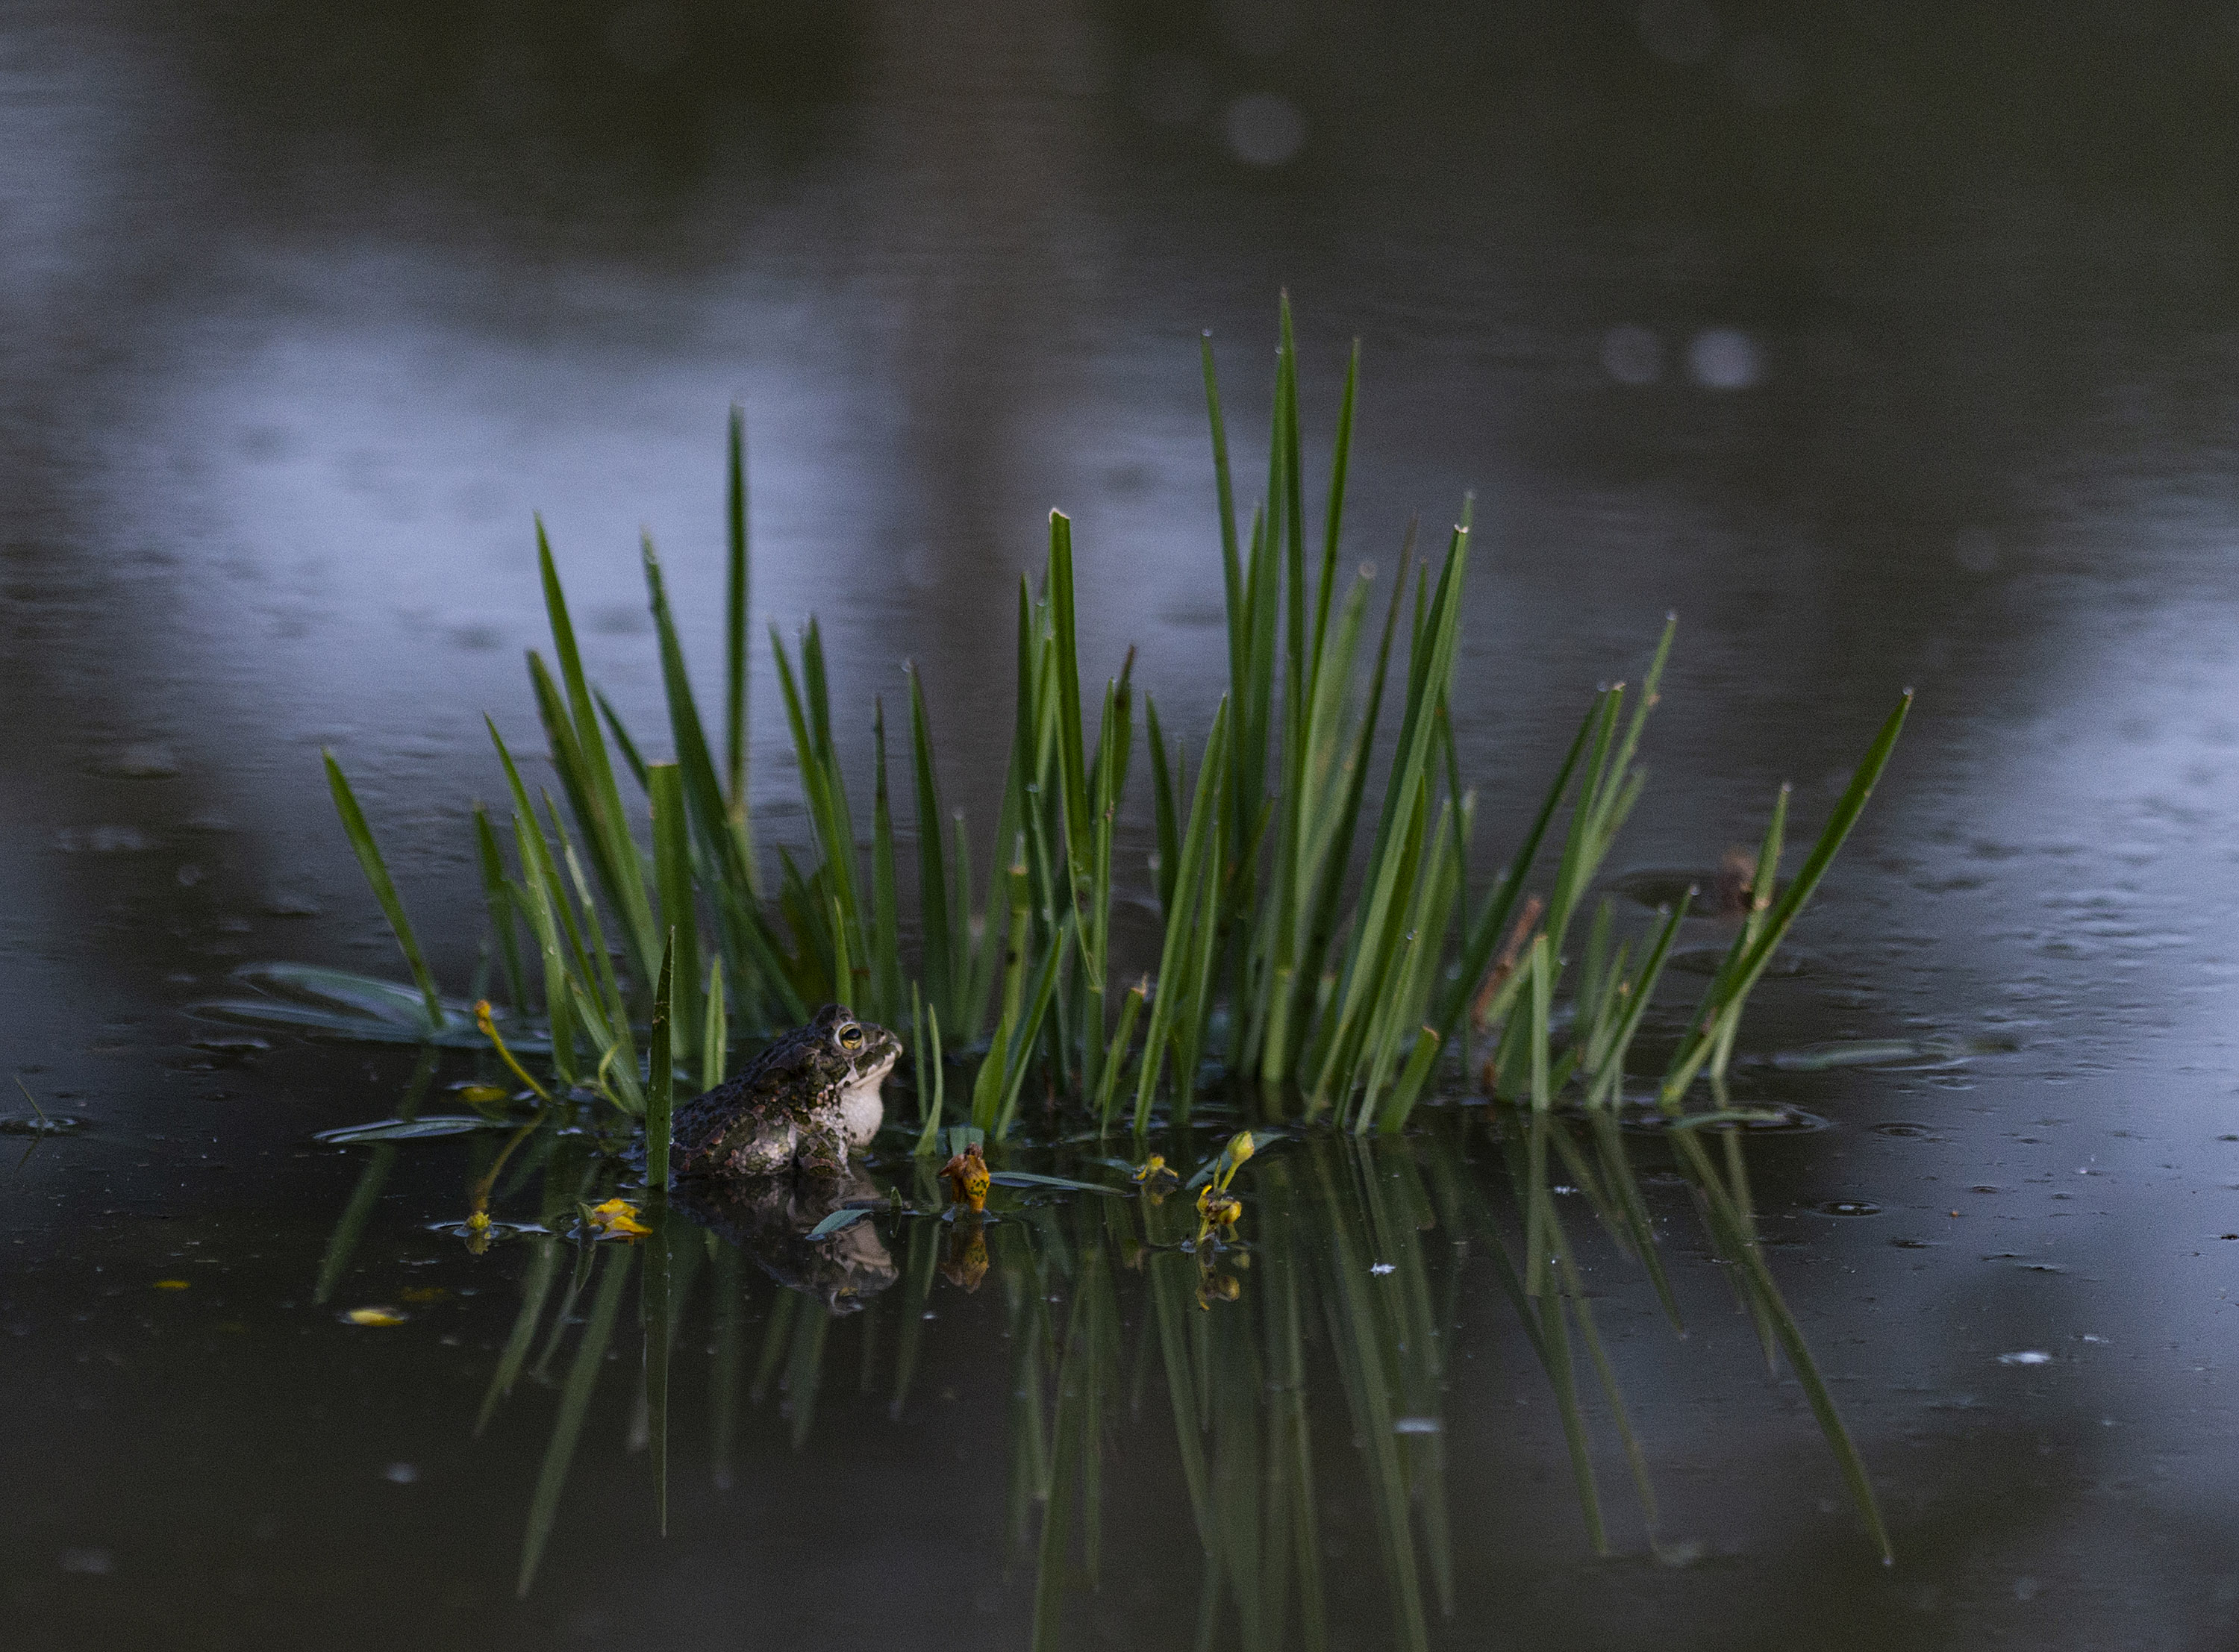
[{"x1": 0, "y1": 0, "x2": 2239, "y2": 1648}]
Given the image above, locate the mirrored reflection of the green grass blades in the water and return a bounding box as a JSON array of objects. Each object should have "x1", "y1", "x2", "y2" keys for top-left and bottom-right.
[{"x1": 327, "y1": 1092, "x2": 1885, "y2": 1621}]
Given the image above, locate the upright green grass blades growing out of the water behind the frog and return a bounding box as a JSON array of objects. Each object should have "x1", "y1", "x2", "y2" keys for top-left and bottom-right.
[{"x1": 289, "y1": 304, "x2": 1910, "y2": 1142}]
